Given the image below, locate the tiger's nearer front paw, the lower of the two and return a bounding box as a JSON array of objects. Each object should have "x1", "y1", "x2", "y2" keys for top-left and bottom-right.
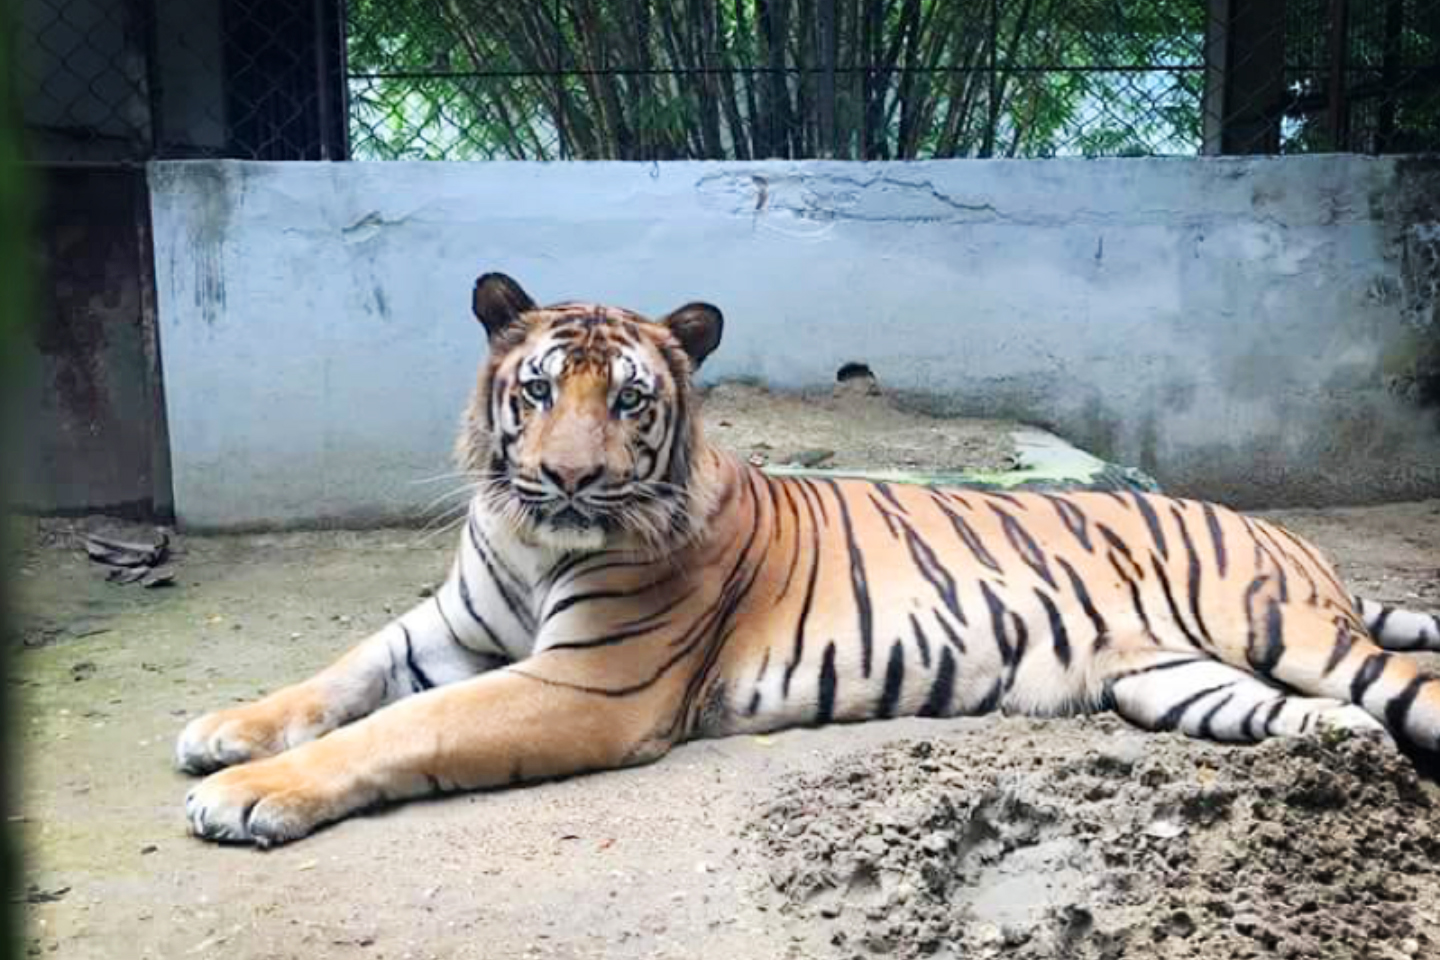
[{"x1": 184, "y1": 757, "x2": 344, "y2": 846}]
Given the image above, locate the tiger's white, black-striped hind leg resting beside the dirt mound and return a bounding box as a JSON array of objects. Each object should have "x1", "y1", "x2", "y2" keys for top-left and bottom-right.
[{"x1": 1106, "y1": 652, "x2": 1385, "y2": 743}]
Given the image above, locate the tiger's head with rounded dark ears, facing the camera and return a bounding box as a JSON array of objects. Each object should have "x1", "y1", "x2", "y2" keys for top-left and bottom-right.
[{"x1": 458, "y1": 273, "x2": 724, "y2": 551}]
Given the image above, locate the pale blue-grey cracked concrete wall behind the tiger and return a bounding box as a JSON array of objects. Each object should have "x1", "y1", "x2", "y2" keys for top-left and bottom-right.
[{"x1": 150, "y1": 157, "x2": 1440, "y2": 527}]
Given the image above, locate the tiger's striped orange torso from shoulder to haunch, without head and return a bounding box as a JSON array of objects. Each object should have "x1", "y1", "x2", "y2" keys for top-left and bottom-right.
[{"x1": 537, "y1": 462, "x2": 1440, "y2": 740}]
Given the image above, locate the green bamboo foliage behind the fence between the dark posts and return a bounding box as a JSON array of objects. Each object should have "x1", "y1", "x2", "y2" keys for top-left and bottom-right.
[{"x1": 348, "y1": 0, "x2": 1207, "y2": 160}]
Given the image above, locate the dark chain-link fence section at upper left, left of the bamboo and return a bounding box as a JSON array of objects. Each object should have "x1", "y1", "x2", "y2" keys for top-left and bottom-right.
[{"x1": 14, "y1": 0, "x2": 346, "y2": 161}]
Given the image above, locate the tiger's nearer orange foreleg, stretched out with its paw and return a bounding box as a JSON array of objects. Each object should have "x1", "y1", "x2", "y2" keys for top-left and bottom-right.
[{"x1": 186, "y1": 653, "x2": 670, "y2": 845}]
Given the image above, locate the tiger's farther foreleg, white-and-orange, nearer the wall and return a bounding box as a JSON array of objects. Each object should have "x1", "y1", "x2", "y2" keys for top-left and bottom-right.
[{"x1": 176, "y1": 594, "x2": 504, "y2": 773}]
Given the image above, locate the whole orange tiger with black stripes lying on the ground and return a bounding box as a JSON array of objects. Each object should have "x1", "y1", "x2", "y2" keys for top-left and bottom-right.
[{"x1": 176, "y1": 273, "x2": 1440, "y2": 846}]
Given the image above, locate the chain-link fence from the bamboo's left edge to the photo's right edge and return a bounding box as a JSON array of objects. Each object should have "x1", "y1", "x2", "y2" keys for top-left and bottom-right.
[{"x1": 347, "y1": 0, "x2": 1440, "y2": 160}]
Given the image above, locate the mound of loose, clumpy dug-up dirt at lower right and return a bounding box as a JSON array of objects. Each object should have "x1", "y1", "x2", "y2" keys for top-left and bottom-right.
[{"x1": 752, "y1": 718, "x2": 1440, "y2": 960}]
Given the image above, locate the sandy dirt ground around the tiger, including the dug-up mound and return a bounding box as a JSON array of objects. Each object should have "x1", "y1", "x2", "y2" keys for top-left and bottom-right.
[{"x1": 6, "y1": 385, "x2": 1440, "y2": 960}]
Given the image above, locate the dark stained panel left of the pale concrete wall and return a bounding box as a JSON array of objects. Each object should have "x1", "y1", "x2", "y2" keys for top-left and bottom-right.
[{"x1": 16, "y1": 167, "x2": 170, "y2": 518}]
